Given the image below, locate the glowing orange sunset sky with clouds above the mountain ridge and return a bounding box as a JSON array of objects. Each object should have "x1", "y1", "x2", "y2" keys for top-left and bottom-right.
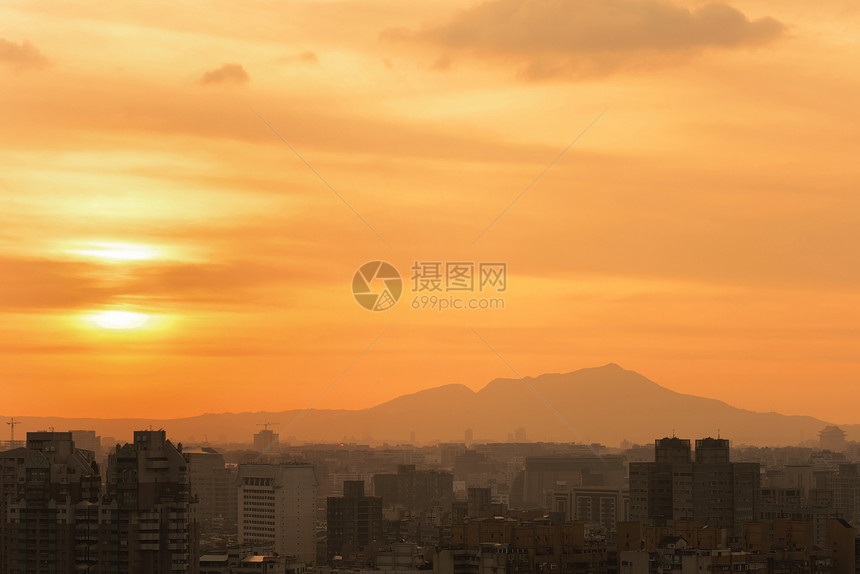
[{"x1": 0, "y1": 0, "x2": 860, "y2": 426}]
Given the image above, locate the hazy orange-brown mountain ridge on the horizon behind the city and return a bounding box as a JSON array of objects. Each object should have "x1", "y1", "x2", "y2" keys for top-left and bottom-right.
[{"x1": 3, "y1": 363, "x2": 860, "y2": 446}]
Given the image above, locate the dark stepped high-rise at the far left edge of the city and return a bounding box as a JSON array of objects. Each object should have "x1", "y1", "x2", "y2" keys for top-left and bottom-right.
[{"x1": 0, "y1": 432, "x2": 101, "y2": 574}]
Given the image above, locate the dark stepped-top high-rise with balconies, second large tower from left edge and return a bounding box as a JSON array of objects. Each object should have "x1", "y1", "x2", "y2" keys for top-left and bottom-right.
[{"x1": 94, "y1": 430, "x2": 198, "y2": 574}]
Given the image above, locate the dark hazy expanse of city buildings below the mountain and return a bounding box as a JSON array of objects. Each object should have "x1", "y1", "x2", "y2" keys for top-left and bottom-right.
[{"x1": 0, "y1": 423, "x2": 860, "y2": 574}]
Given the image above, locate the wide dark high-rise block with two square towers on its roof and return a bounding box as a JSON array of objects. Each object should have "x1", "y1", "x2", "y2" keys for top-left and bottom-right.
[{"x1": 629, "y1": 437, "x2": 761, "y2": 536}]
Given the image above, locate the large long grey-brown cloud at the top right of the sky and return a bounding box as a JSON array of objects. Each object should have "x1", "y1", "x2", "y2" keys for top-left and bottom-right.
[{"x1": 383, "y1": 0, "x2": 784, "y2": 77}]
